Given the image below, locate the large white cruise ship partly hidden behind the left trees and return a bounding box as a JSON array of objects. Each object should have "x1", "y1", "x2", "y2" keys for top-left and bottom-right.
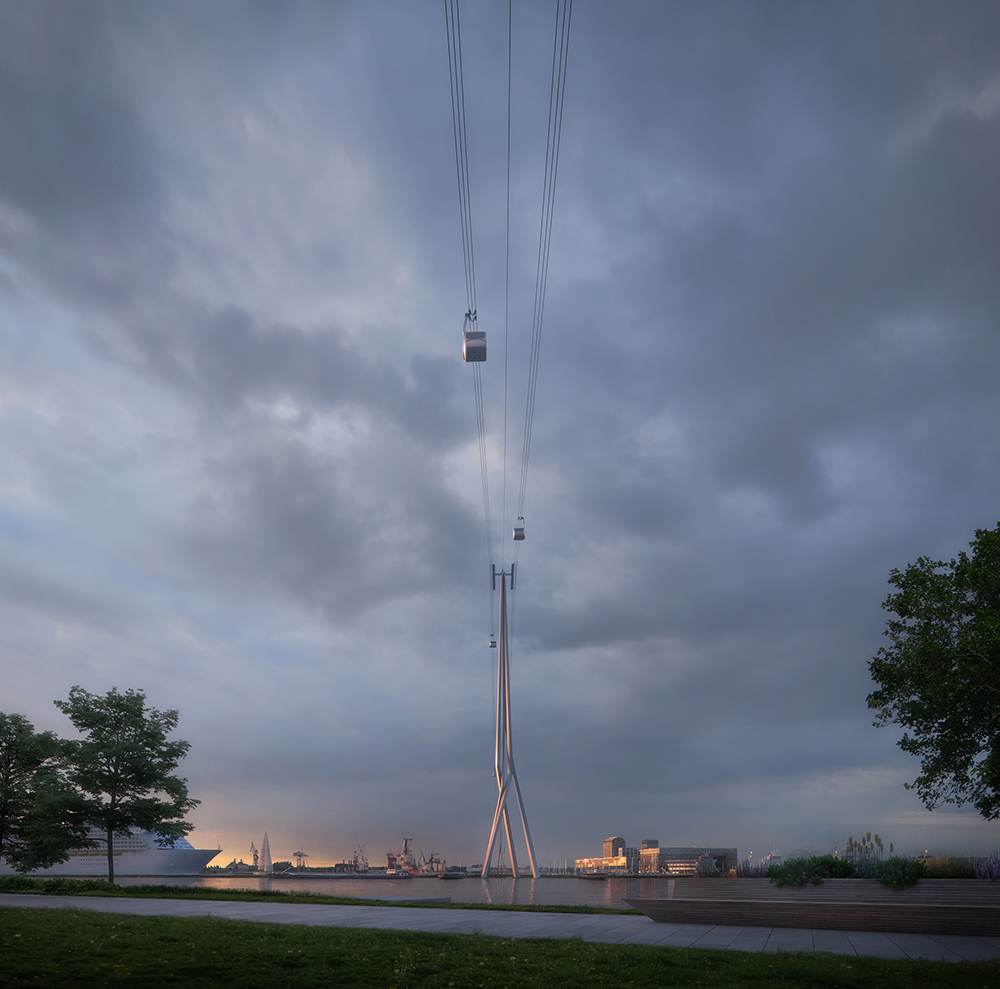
[{"x1": 0, "y1": 828, "x2": 219, "y2": 876}]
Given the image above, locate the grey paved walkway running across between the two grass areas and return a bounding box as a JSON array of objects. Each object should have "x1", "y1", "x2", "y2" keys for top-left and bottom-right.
[{"x1": 0, "y1": 893, "x2": 1000, "y2": 962}]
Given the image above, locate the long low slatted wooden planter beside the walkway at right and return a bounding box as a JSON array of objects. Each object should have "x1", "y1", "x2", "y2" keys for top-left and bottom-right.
[{"x1": 625, "y1": 879, "x2": 1000, "y2": 936}]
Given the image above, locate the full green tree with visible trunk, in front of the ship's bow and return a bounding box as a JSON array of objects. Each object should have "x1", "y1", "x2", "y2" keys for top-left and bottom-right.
[{"x1": 55, "y1": 687, "x2": 199, "y2": 882}]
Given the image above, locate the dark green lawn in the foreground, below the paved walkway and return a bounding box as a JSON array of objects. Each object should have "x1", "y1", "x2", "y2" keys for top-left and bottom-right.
[{"x1": 0, "y1": 907, "x2": 1000, "y2": 989}]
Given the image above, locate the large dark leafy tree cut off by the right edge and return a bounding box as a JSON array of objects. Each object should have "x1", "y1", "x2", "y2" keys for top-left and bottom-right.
[{"x1": 868, "y1": 523, "x2": 1000, "y2": 820}]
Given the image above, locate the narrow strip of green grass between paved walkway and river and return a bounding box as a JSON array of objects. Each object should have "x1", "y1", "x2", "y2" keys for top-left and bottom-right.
[{"x1": 0, "y1": 876, "x2": 640, "y2": 915}]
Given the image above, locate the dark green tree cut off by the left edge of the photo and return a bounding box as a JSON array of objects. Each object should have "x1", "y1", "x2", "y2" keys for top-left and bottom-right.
[{"x1": 0, "y1": 712, "x2": 88, "y2": 872}]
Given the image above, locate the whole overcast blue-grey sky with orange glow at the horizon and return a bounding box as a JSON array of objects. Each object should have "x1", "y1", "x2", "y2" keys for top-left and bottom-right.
[{"x1": 0, "y1": 0, "x2": 1000, "y2": 864}]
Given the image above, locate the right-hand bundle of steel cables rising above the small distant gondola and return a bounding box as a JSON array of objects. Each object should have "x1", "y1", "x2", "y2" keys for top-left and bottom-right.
[{"x1": 517, "y1": 0, "x2": 573, "y2": 516}]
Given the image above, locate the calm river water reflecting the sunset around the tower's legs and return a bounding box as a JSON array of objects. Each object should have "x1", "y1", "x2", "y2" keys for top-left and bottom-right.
[{"x1": 117, "y1": 876, "x2": 670, "y2": 909}]
